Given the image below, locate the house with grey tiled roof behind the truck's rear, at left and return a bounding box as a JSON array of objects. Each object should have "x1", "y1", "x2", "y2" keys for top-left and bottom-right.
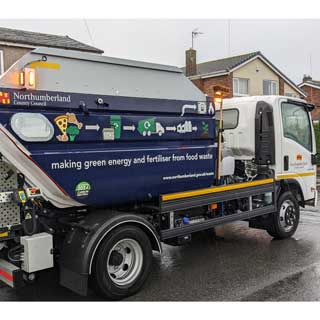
[{"x1": 0, "y1": 28, "x2": 103, "y2": 74}]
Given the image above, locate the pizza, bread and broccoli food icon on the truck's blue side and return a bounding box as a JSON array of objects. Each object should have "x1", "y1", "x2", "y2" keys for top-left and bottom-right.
[{"x1": 54, "y1": 112, "x2": 83, "y2": 142}]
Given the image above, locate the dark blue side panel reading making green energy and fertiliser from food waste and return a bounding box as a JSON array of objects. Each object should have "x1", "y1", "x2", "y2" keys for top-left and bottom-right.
[{"x1": 0, "y1": 89, "x2": 216, "y2": 207}]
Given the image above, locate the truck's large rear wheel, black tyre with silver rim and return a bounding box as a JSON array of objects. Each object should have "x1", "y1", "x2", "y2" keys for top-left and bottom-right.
[{"x1": 92, "y1": 226, "x2": 152, "y2": 300}]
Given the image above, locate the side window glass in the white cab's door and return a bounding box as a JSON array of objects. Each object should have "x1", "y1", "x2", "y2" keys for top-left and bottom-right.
[{"x1": 281, "y1": 102, "x2": 312, "y2": 152}]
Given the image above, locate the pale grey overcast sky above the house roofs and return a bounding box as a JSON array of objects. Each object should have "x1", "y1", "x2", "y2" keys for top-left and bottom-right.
[{"x1": 0, "y1": 19, "x2": 320, "y2": 83}]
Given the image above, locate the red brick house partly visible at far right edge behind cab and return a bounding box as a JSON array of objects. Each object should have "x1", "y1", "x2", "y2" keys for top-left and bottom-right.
[{"x1": 299, "y1": 75, "x2": 320, "y2": 121}]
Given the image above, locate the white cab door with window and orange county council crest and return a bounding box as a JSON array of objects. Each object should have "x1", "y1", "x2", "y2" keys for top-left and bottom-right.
[{"x1": 276, "y1": 100, "x2": 316, "y2": 200}]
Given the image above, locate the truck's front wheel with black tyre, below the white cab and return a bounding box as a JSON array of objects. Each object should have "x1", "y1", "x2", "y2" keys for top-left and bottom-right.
[{"x1": 267, "y1": 191, "x2": 300, "y2": 239}]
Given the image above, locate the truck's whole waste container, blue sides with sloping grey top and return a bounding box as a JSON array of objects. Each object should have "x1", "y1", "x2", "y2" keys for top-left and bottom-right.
[{"x1": 0, "y1": 49, "x2": 216, "y2": 208}]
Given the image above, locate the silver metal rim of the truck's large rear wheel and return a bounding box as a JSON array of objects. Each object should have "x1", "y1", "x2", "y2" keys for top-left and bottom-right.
[{"x1": 107, "y1": 239, "x2": 143, "y2": 286}]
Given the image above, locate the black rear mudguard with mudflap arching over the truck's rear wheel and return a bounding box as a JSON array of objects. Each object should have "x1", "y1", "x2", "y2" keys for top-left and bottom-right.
[{"x1": 59, "y1": 210, "x2": 161, "y2": 295}]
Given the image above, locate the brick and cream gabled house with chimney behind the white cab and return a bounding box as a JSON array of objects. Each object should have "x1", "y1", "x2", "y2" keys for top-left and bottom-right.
[{"x1": 182, "y1": 49, "x2": 306, "y2": 98}]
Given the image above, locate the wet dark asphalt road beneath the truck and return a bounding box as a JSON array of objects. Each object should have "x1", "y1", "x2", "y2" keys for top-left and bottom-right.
[{"x1": 0, "y1": 208, "x2": 320, "y2": 301}]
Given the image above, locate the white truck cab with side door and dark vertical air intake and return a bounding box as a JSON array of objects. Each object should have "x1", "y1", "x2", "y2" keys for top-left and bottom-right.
[{"x1": 217, "y1": 96, "x2": 317, "y2": 205}]
